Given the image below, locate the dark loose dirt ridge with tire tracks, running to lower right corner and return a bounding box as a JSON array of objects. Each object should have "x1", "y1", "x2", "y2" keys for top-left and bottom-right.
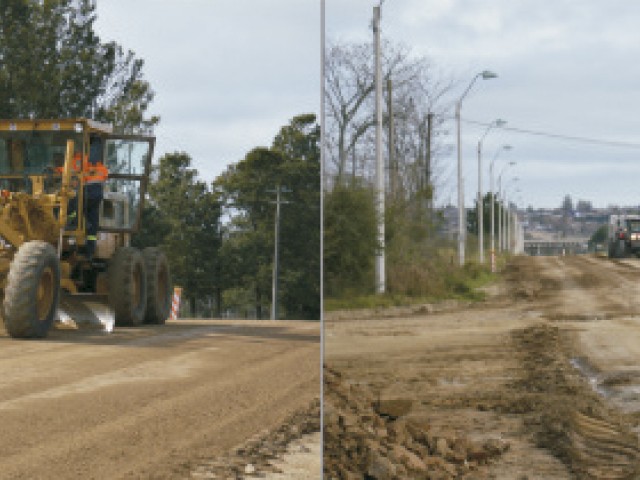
[{"x1": 512, "y1": 323, "x2": 640, "y2": 480}]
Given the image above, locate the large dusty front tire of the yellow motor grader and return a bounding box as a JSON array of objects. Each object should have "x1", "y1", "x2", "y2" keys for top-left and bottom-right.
[{"x1": 2, "y1": 240, "x2": 60, "y2": 338}]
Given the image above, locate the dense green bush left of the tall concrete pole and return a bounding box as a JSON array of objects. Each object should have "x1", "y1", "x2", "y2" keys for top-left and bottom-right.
[{"x1": 324, "y1": 183, "x2": 378, "y2": 297}]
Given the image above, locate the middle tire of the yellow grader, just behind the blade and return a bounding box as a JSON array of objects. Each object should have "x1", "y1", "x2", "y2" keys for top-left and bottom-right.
[{"x1": 107, "y1": 247, "x2": 147, "y2": 327}]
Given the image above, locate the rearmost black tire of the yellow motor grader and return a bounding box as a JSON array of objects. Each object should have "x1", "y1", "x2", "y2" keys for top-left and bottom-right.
[{"x1": 142, "y1": 247, "x2": 172, "y2": 325}]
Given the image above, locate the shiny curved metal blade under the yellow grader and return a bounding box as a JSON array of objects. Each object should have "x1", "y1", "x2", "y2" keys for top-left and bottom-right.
[{"x1": 58, "y1": 293, "x2": 115, "y2": 332}]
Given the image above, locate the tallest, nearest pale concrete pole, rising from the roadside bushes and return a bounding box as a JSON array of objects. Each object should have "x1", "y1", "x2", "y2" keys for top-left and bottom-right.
[{"x1": 373, "y1": 5, "x2": 386, "y2": 293}]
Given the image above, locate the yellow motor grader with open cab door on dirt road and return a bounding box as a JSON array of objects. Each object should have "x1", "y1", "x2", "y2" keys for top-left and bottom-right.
[{"x1": 0, "y1": 118, "x2": 171, "y2": 338}]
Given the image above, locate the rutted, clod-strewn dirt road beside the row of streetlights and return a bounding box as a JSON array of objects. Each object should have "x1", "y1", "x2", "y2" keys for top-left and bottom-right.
[{"x1": 325, "y1": 257, "x2": 640, "y2": 480}]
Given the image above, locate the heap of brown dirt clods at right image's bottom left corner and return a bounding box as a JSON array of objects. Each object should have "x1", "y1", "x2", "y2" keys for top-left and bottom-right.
[{"x1": 324, "y1": 366, "x2": 509, "y2": 480}]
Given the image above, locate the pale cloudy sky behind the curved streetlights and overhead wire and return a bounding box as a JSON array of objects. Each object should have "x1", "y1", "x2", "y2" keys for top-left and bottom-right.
[{"x1": 327, "y1": 0, "x2": 640, "y2": 207}]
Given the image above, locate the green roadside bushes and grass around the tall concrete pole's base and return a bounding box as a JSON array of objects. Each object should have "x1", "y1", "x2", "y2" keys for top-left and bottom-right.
[{"x1": 324, "y1": 179, "x2": 494, "y2": 310}]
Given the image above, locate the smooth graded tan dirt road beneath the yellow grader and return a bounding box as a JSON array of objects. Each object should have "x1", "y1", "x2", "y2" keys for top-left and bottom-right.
[{"x1": 0, "y1": 320, "x2": 320, "y2": 479}]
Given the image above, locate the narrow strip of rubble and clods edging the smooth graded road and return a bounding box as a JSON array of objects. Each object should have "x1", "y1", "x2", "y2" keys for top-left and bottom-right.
[{"x1": 188, "y1": 400, "x2": 320, "y2": 480}]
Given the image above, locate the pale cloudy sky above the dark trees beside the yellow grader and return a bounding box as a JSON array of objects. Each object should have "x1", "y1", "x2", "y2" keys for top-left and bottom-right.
[{"x1": 95, "y1": 0, "x2": 320, "y2": 184}]
